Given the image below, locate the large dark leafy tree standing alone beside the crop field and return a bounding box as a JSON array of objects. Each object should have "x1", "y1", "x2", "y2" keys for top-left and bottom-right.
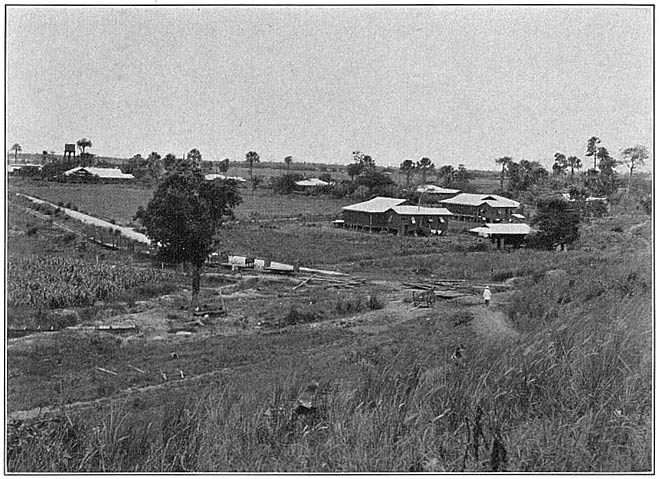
[{"x1": 135, "y1": 160, "x2": 241, "y2": 308}]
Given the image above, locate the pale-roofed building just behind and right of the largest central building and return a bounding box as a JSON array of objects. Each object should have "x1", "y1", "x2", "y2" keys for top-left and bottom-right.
[{"x1": 440, "y1": 193, "x2": 519, "y2": 223}]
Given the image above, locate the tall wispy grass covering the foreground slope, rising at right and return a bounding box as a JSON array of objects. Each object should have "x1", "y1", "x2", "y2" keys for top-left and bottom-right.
[{"x1": 8, "y1": 251, "x2": 653, "y2": 472}]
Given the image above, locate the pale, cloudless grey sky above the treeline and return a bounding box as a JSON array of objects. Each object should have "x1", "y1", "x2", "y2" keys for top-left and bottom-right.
[{"x1": 5, "y1": 6, "x2": 654, "y2": 170}]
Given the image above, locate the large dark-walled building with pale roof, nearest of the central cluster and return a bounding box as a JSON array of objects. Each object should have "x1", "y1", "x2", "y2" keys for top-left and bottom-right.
[{"x1": 334, "y1": 196, "x2": 451, "y2": 236}]
